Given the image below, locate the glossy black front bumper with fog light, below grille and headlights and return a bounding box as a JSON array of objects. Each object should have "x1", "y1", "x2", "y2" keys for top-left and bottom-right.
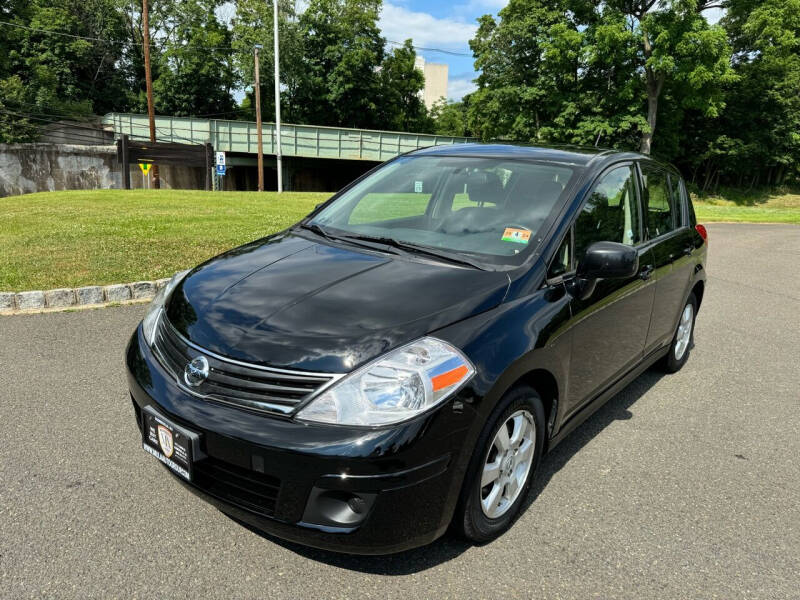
[{"x1": 126, "y1": 328, "x2": 474, "y2": 554}]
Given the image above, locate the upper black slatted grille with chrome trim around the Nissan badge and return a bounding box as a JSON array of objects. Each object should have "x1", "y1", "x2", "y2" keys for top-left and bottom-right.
[{"x1": 153, "y1": 314, "x2": 337, "y2": 414}]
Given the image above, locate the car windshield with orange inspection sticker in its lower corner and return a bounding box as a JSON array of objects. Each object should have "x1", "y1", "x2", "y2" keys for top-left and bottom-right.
[{"x1": 310, "y1": 156, "x2": 578, "y2": 265}]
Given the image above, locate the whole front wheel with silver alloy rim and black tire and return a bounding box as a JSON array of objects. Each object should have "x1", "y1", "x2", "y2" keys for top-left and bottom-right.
[{"x1": 454, "y1": 386, "x2": 545, "y2": 543}]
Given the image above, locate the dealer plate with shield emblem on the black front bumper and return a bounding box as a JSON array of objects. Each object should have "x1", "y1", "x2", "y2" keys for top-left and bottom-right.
[{"x1": 142, "y1": 406, "x2": 201, "y2": 481}]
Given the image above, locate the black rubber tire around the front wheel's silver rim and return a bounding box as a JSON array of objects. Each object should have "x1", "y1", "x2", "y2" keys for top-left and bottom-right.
[{"x1": 453, "y1": 385, "x2": 545, "y2": 544}]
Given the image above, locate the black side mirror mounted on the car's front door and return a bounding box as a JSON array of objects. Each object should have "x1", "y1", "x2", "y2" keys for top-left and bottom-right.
[{"x1": 570, "y1": 242, "x2": 639, "y2": 300}]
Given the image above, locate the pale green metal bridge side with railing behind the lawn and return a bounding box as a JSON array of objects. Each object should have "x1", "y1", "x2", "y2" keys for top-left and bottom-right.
[{"x1": 103, "y1": 113, "x2": 475, "y2": 161}]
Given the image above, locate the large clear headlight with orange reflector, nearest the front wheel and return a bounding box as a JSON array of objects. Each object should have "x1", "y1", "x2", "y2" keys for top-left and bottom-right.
[{"x1": 297, "y1": 337, "x2": 475, "y2": 426}]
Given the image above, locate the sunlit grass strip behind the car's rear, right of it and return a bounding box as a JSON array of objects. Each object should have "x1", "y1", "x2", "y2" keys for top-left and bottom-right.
[{"x1": 692, "y1": 190, "x2": 800, "y2": 225}]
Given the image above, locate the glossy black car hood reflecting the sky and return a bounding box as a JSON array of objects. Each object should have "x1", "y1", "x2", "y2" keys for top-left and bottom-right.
[{"x1": 167, "y1": 232, "x2": 509, "y2": 373}]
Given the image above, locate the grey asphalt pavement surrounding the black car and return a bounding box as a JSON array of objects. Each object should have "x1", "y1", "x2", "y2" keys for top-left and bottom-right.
[{"x1": 0, "y1": 224, "x2": 800, "y2": 600}]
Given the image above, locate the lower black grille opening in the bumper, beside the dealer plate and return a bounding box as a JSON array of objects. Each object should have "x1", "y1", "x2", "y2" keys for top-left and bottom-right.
[{"x1": 193, "y1": 457, "x2": 281, "y2": 517}]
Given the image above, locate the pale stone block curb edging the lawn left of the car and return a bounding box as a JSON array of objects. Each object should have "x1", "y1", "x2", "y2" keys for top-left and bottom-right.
[{"x1": 0, "y1": 277, "x2": 169, "y2": 314}]
